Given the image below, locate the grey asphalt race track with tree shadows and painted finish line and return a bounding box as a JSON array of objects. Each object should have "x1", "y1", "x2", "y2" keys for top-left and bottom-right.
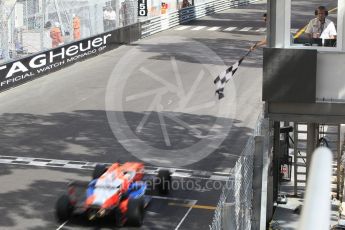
[{"x1": 0, "y1": 1, "x2": 266, "y2": 230}]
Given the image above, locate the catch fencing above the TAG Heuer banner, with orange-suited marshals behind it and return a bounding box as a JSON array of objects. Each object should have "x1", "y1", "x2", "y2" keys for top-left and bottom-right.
[{"x1": 0, "y1": 0, "x2": 138, "y2": 62}]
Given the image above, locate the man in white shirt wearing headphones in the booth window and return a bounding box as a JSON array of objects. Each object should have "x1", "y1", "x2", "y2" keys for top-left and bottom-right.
[{"x1": 305, "y1": 6, "x2": 337, "y2": 39}]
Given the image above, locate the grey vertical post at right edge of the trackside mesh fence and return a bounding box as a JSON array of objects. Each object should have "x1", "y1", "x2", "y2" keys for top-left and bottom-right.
[{"x1": 251, "y1": 136, "x2": 264, "y2": 230}]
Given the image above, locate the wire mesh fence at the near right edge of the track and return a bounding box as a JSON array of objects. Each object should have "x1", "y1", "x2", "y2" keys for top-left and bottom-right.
[{"x1": 210, "y1": 115, "x2": 263, "y2": 230}]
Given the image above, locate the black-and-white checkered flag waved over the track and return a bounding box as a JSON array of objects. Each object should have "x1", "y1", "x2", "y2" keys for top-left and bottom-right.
[{"x1": 213, "y1": 47, "x2": 256, "y2": 100}]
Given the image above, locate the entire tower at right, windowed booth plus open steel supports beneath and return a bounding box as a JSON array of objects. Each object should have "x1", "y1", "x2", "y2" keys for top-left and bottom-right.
[{"x1": 262, "y1": 0, "x2": 345, "y2": 227}]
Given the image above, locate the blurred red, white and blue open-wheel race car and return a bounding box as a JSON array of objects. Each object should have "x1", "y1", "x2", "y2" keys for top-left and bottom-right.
[{"x1": 55, "y1": 162, "x2": 171, "y2": 227}]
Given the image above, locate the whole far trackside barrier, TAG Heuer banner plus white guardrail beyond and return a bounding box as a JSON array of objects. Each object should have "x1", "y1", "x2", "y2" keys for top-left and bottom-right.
[{"x1": 0, "y1": 0, "x2": 259, "y2": 92}]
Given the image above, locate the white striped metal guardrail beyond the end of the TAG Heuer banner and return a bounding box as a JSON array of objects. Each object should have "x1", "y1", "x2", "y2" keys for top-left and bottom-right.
[{"x1": 141, "y1": 0, "x2": 259, "y2": 38}]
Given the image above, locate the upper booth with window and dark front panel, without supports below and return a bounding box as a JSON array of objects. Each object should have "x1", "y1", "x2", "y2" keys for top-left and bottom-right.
[{"x1": 263, "y1": 0, "x2": 345, "y2": 118}]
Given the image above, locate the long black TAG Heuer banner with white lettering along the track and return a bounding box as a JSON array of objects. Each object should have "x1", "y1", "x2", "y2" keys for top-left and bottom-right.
[{"x1": 0, "y1": 23, "x2": 140, "y2": 92}]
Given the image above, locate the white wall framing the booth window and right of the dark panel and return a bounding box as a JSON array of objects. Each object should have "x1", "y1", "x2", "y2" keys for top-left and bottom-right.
[{"x1": 268, "y1": 0, "x2": 345, "y2": 101}]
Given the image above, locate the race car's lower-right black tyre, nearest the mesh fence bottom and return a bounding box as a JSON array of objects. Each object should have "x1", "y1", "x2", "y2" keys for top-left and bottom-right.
[{"x1": 126, "y1": 198, "x2": 144, "y2": 227}]
